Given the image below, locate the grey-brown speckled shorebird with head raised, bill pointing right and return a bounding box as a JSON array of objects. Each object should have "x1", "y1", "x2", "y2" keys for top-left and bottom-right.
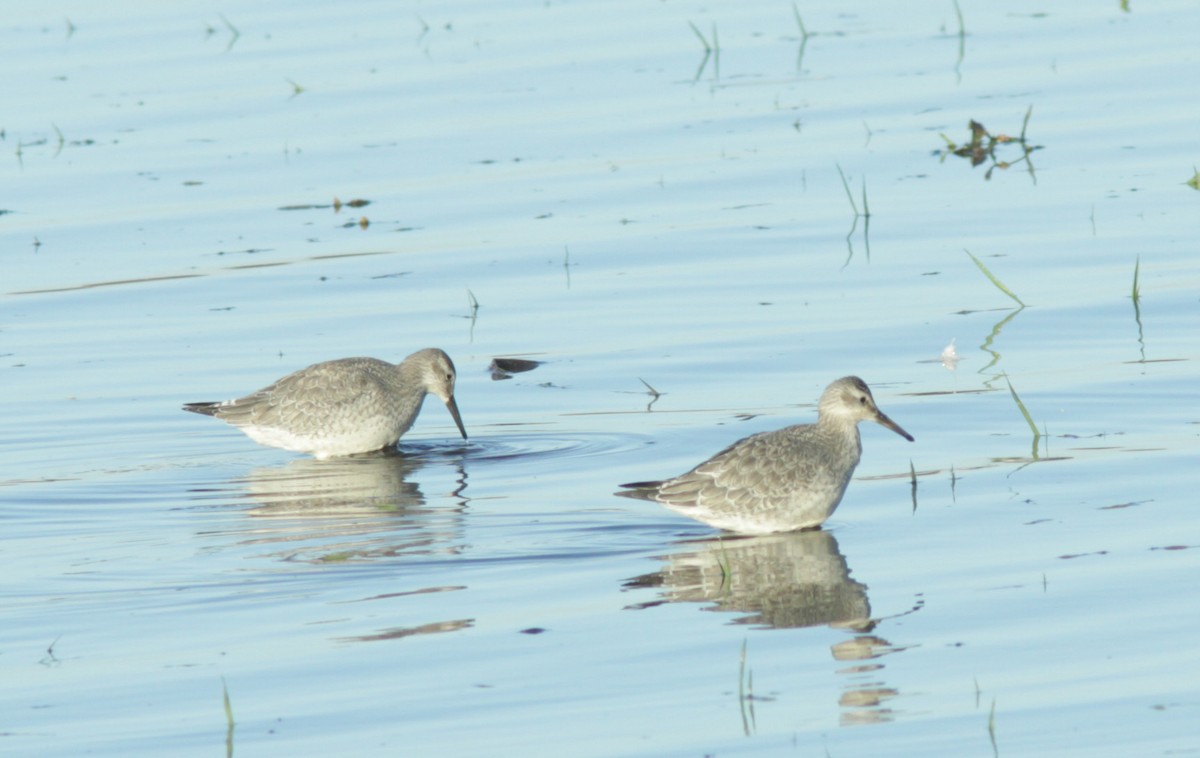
[{"x1": 617, "y1": 377, "x2": 912, "y2": 534}]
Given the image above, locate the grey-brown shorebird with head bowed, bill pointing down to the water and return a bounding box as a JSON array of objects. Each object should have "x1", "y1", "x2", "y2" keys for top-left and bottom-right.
[{"x1": 184, "y1": 348, "x2": 467, "y2": 458}]
